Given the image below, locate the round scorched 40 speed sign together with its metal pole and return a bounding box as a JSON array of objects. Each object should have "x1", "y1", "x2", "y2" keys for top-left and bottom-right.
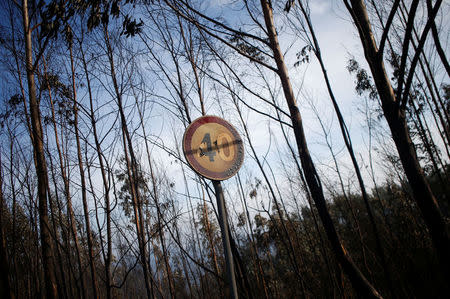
[{"x1": 183, "y1": 116, "x2": 244, "y2": 299}]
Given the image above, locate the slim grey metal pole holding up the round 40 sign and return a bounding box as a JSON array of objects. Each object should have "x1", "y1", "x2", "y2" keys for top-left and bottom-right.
[{"x1": 212, "y1": 180, "x2": 238, "y2": 299}]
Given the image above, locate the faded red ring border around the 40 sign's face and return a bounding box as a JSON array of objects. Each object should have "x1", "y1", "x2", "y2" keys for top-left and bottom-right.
[{"x1": 183, "y1": 115, "x2": 244, "y2": 181}]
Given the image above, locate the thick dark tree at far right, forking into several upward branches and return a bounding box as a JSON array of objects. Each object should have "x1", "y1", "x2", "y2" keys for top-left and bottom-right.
[{"x1": 344, "y1": 0, "x2": 450, "y2": 273}]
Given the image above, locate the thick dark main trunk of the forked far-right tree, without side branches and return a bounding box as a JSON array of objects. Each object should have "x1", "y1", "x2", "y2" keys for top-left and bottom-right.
[{"x1": 346, "y1": 0, "x2": 450, "y2": 273}]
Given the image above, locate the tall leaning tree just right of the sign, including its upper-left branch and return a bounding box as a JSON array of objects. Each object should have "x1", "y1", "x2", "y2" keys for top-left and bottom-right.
[{"x1": 160, "y1": 0, "x2": 380, "y2": 298}]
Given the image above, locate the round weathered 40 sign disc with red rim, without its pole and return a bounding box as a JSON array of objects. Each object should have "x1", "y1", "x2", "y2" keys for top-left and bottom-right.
[{"x1": 183, "y1": 116, "x2": 244, "y2": 181}]
